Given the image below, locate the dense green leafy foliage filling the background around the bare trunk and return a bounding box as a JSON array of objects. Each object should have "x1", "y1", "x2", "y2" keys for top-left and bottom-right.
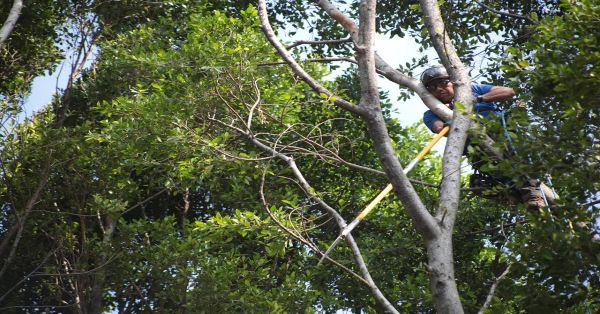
[{"x1": 0, "y1": 0, "x2": 600, "y2": 313}]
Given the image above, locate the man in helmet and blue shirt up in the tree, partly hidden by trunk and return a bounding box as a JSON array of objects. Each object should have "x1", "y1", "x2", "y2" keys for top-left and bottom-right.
[{"x1": 421, "y1": 66, "x2": 554, "y2": 209}]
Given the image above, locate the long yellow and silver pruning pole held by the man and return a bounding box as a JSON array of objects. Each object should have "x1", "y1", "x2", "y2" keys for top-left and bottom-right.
[{"x1": 319, "y1": 126, "x2": 450, "y2": 264}]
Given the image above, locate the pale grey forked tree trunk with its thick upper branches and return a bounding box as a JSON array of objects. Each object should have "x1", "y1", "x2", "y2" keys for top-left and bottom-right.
[{"x1": 259, "y1": 0, "x2": 502, "y2": 313}]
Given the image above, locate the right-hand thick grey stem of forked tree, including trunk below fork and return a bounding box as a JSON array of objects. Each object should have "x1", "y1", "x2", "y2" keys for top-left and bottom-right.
[{"x1": 420, "y1": 0, "x2": 473, "y2": 313}]
